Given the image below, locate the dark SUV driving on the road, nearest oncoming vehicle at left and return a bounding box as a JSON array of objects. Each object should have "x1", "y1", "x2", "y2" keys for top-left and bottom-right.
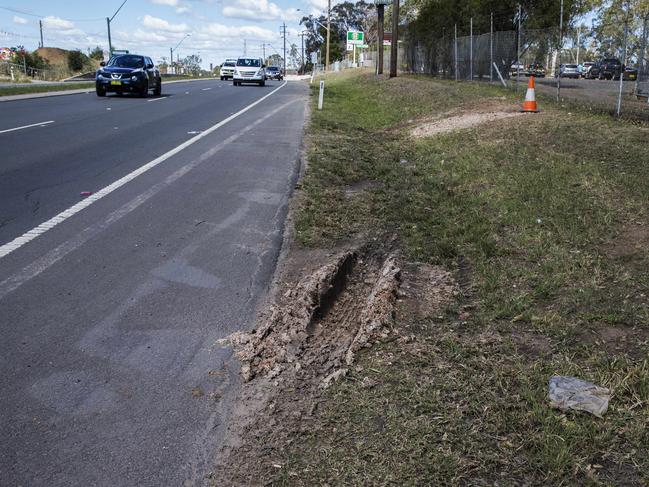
[{"x1": 95, "y1": 54, "x2": 162, "y2": 97}]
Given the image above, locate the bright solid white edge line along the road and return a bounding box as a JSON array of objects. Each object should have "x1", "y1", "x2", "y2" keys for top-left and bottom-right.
[{"x1": 0, "y1": 83, "x2": 286, "y2": 259}]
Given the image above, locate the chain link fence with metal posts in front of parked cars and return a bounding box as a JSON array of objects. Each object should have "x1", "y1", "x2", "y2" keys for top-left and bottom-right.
[{"x1": 364, "y1": 9, "x2": 649, "y2": 119}]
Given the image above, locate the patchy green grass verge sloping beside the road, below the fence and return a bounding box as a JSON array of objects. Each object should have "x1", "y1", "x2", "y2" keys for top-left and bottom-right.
[{"x1": 281, "y1": 72, "x2": 649, "y2": 485}]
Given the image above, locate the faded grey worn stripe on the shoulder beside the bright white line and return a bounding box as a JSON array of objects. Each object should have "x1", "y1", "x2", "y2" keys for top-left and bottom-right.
[{"x1": 0, "y1": 96, "x2": 295, "y2": 299}]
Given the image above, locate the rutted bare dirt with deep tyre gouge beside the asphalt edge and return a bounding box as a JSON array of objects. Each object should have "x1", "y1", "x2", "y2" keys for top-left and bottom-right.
[{"x1": 211, "y1": 248, "x2": 459, "y2": 487}]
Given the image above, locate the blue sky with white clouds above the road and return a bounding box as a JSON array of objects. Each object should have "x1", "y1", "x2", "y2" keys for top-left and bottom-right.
[{"x1": 0, "y1": 0, "x2": 337, "y2": 68}]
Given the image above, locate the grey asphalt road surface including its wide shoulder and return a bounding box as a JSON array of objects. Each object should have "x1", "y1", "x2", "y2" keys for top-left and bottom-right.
[{"x1": 0, "y1": 80, "x2": 307, "y2": 487}]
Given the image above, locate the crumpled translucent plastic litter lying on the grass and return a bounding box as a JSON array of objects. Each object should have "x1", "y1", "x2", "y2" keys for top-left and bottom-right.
[{"x1": 548, "y1": 375, "x2": 611, "y2": 418}]
